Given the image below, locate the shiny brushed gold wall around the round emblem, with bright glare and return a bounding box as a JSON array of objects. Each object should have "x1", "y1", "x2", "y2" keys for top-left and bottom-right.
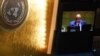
[{"x1": 0, "y1": 0, "x2": 54, "y2": 56}]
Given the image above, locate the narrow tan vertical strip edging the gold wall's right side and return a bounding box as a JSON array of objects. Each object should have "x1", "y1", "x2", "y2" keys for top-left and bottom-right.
[{"x1": 47, "y1": 0, "x2": 59, "y2": 54}]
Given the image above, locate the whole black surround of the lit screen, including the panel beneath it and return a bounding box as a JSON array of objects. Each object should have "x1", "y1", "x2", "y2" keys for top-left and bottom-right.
[{"x1": 52, "y1": 1, "x2": 97, "y2": 54}]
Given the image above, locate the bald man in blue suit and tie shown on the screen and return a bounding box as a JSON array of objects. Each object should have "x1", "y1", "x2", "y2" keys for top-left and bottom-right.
[{"x1": 69, "y1": 14, "x2": 86, "y2": 31}]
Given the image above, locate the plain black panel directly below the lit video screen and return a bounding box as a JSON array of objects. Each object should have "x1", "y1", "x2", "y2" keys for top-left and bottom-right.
[{"x1": 52, "y1": 31, "x2": 93, "y2": 54}]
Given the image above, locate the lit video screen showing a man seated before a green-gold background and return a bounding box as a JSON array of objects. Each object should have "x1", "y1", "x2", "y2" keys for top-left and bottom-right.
[{"x1": 61, "y1": 11, "x2": 94, "y2": 32}]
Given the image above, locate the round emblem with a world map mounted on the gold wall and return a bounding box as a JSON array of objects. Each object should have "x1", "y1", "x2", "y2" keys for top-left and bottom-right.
[{"x1": 0, "y1": 0, "x2": 28, "y2": 30}]
